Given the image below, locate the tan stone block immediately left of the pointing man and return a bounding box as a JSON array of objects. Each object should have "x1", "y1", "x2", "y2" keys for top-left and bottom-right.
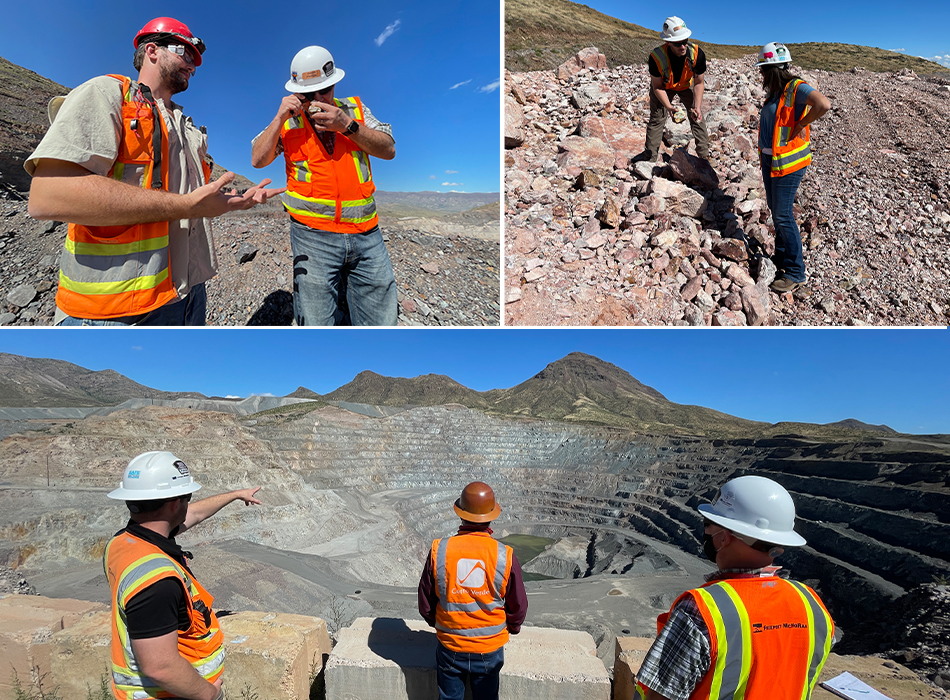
[{"x1": 50, "y1": 610, "x2": 112, "y2": 698}]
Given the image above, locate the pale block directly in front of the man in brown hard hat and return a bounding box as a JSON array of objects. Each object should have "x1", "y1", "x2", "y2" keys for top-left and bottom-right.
[{"x1": 326, "y1": 617, "x2": 610, "y2": 700}]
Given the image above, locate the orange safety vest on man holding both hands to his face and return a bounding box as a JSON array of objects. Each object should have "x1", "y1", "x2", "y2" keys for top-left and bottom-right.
[{"x1": 280, "y1": 97, "x2": 379, "y2": 233}]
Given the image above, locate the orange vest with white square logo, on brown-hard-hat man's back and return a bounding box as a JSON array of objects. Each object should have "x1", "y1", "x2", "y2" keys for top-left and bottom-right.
[{"x1": 431, "y1": 532, "x2": 512, "y2": 654}]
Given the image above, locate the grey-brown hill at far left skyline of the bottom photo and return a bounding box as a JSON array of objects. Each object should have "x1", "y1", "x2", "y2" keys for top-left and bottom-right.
[{"x1": 0, "y1": 353, "x2": 205, "y2": 408}]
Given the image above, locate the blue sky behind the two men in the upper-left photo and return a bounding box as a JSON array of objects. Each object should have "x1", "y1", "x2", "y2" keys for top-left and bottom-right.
[{"x1": 0, "y1": 0, "x2": 501, "y2": 192}]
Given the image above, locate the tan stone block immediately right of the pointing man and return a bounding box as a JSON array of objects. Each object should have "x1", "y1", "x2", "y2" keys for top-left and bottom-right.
[{"x1": 220, "y1": 612, "x2": 331, "y2": 700}]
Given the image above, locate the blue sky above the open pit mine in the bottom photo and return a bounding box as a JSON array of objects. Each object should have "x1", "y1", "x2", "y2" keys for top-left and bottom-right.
[{"x1": 0, "y1": 328, "x2": 950, "y2": 434}]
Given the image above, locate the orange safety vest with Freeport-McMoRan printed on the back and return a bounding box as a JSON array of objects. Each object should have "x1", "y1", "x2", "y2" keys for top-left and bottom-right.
[{"x1": 637, "y1": 576, "x2": 835, "y2": 700}]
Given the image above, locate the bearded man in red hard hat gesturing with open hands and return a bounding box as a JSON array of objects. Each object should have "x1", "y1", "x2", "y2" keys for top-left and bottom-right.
[{"x1": 24, "y1": 17, "x2": 283, "y2": 326}]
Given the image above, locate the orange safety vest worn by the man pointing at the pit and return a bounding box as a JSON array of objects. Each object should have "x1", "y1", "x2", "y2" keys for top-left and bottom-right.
[{"x1": 103, "y1": 532, "x2": 224, "y2": 700}]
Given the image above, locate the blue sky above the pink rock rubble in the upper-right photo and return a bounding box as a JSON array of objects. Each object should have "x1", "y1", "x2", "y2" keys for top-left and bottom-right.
[{"x1": 584, "y1": 0, "x2": 950, "y2": 66}]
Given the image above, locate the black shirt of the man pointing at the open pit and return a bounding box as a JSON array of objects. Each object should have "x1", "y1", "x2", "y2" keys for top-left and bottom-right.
[{"x1": 116, "y1": 521, "x2": 191, "y2": 639}]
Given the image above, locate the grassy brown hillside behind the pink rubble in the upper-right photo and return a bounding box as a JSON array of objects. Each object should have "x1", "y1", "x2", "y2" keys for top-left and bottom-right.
[{"x1": 505, "y1": 0, "x2": 950, "y2": 75}]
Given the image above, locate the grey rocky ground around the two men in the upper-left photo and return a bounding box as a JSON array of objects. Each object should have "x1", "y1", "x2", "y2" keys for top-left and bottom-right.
[{"x1": 0, "y1": 198, "x2": 500, "y2": 326}]
